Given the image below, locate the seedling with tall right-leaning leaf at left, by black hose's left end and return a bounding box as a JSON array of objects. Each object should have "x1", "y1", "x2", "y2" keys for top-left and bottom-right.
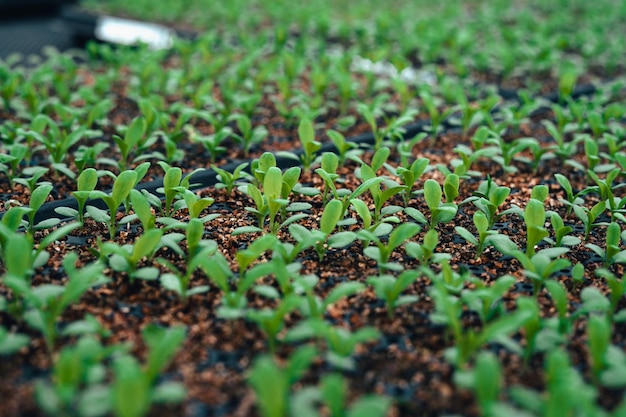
[{"x1": 87, "y1": 171, "x2": 138, "y2": 239}]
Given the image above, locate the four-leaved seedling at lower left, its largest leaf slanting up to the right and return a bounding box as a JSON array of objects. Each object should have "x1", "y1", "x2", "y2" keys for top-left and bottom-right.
[{"x1": 100, "y1": 229, "x2": 163, "y2": 283}]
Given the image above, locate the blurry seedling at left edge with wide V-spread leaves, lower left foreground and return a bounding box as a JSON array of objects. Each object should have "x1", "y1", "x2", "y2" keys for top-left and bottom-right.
[{"x1": 3, "y1": 253, "x2": 109, "y2": 353}]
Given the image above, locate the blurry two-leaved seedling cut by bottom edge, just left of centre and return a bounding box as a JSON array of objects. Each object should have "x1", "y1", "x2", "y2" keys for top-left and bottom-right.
[{"x1": 248, "y1": 346, "x2": 317, "y2": 417}]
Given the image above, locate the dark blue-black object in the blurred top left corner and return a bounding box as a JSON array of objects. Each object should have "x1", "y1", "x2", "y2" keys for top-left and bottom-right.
[{"x1": 0, "y1": 0, "x2": 79, "y2": 59}]
